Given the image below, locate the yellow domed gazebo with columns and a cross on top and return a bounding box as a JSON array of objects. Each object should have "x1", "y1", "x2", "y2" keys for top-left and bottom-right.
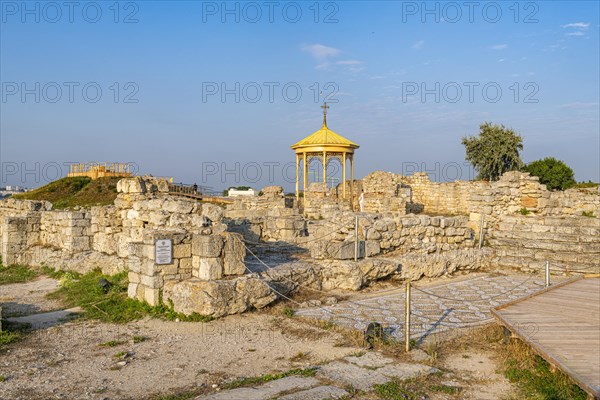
[{"x1": 291, "y1": 102, "x2": 359, "y2": 199}]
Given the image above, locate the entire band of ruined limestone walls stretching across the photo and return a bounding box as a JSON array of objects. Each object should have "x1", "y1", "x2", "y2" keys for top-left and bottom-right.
[{"x1": 0, "y1": 171, "x2": 600, "y2": 316}]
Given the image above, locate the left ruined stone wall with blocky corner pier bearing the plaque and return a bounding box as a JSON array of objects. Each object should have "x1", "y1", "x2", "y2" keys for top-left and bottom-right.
[{"x1": 0, "y1": 178, "x2": 275, "y2": 316}]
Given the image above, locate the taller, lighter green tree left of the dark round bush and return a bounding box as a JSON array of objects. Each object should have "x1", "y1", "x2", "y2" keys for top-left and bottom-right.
[{"x1": 462, "y1": 122, "x2": 523, "y2": 181}]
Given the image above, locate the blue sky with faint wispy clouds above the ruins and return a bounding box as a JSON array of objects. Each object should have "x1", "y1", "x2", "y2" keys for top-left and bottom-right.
[{"x1": 0, "y1": 1, "x2": 600, "y2": 190}]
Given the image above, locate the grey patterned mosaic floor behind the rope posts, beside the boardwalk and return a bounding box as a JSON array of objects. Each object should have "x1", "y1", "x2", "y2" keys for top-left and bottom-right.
[{"x1": 296, "y1": 275, "x2": 544, "y2": 340}]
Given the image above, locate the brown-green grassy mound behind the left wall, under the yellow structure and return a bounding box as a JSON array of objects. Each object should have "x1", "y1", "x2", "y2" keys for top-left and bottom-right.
[{"x1": 13, "y1": 177, "x2": 121, "y2": 209}]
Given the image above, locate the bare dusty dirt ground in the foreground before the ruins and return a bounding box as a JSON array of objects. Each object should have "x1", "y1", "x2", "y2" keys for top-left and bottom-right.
[{"x1": 0, "y1": 278, "x2": 512, "y2": 400}]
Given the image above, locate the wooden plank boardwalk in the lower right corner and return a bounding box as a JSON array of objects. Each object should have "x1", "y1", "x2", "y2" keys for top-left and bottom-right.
[{"x1": 492, "y1": 277, "x2": 600, "y2": 399}]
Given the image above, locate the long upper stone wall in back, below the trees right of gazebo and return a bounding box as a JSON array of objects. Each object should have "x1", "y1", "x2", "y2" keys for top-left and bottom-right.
[{"x1": 354, "y1": 171, "x2": 600, "y2": 233}]
